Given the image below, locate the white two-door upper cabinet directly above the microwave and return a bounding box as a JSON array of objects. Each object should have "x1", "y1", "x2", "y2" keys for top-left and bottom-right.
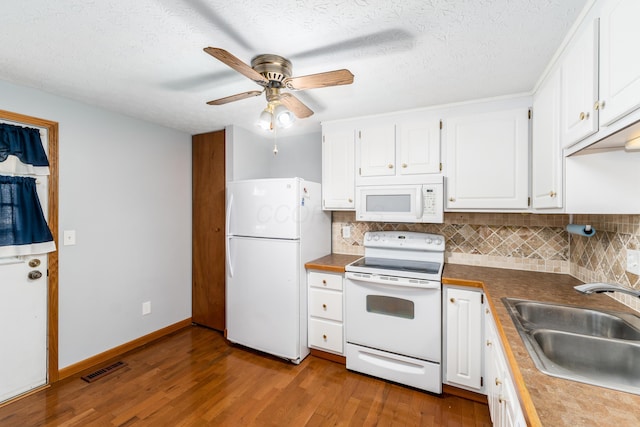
[{"x1": 356, "y1": 113, "x2": 440, "y2": 185}]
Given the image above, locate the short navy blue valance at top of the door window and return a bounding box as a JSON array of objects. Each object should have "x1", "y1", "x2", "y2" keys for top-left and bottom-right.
[{"x1": 0, "y1": 123, "x2": 49, "y2": 175}]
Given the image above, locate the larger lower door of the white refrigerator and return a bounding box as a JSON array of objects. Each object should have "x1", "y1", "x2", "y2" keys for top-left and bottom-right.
[{"x1": 226, "y1": 237, "x2": 306, "y2": 360}]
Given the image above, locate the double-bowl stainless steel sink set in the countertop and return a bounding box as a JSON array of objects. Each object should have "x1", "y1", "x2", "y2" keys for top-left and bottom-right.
[{"x1": 502, "y1": 298, "x2": 640, "y2": 394}]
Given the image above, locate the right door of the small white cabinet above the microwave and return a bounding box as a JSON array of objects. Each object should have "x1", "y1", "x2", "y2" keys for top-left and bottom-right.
[{"x1": 396, "y1": 118, "x2": 440, "y2": 175}]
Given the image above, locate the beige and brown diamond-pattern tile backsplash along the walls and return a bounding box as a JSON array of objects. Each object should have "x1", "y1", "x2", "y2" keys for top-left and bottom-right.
[{"x1": 332, "y1": 211, "x2": 640, "y2": 311}]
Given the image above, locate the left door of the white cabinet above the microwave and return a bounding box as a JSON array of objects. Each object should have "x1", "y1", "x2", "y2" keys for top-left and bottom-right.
[{"x1": 358, "y1": 123, "x2": 396, "y2": 176}]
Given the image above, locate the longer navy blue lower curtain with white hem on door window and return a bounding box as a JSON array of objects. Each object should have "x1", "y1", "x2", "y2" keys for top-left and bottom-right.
[{"x1": 0, "y1": 175, "x2": 56, "y2": 257}]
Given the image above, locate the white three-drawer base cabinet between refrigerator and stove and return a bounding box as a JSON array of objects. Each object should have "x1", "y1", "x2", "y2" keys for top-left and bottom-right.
[{"x1": 307, "y1": 270, "x2": 344, "y2": 355}]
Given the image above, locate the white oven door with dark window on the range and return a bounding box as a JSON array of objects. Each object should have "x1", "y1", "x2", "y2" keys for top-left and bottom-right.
[{"x1": 345, "y1": 272, "x2": 442, "y2": 363}]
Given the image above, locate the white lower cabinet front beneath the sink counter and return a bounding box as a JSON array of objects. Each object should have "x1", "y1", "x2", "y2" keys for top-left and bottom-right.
[{"x1": 484, "y1": 308, "x2": 527, "y2": 427}]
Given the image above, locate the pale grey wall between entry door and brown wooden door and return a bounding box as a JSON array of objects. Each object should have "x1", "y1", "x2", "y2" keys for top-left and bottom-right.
[{"x1": 0, "y1": 81, "x2": 191, "y2": 368}]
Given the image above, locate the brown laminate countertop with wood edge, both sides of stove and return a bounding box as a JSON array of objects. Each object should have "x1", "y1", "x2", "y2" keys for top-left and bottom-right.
[{"x1": 305, "y1": 254, "x2": 640, "y2": 427}]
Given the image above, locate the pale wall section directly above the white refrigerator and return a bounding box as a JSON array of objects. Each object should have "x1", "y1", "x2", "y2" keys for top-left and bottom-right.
[{"x1": 226, "y1": 124, "x2": 322, "y2": 182}]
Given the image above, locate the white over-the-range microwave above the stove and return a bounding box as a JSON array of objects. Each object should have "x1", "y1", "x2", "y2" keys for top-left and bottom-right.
[{"x1": 356, "y1": 175, "x2": 444, "y2": 224}]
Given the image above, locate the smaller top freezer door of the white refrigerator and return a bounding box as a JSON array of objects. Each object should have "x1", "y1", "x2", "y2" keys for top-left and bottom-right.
[{"x1": 227, "y1": 178, "x2": 305, "y2": 239}]
